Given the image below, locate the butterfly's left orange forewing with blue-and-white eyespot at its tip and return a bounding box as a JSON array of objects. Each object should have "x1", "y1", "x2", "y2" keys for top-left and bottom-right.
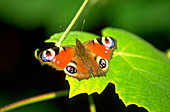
[{"x1": 38, "y1": 46, "x2": 75, "y2": 70}]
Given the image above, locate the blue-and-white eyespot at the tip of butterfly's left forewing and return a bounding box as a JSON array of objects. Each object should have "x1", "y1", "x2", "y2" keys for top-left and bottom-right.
[{"x1": 41, "y1": 49, "x2": 55, "y2": 62}]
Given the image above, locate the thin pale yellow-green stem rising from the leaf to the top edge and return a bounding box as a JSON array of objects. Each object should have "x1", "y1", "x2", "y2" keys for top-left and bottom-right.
[{"x1": 57, "y1": 0, "x2": 88, "y2": 47}]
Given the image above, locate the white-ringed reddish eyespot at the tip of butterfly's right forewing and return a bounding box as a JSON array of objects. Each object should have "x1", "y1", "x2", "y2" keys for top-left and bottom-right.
[{"x1": 102, "y1": 37, "x2": 115, "y2": 48}]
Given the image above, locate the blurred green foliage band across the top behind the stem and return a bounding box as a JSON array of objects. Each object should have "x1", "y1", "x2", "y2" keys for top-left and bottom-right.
[{"x1": 0, "y1": 0, "x2": 170, "y2": 41}]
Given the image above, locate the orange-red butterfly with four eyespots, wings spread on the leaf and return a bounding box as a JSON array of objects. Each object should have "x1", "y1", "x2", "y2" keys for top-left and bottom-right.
[{"x1": 38, "y1": 37, "x2": 117, "y2": 80}]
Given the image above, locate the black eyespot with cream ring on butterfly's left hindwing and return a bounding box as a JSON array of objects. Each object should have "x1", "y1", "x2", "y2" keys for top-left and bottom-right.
[{"x1": 64, "y1": 62, "x2": 77, "y2": 76}]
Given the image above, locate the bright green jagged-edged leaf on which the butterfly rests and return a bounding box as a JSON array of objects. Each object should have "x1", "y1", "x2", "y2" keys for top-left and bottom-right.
[{"x1": 46, "y1": 28, "x2": 170, "y2": 112}]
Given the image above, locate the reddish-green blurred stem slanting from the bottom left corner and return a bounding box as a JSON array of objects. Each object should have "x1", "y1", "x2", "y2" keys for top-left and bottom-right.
[{"x1": 0, "y1": 90, "x2": 69, "y2": 112}]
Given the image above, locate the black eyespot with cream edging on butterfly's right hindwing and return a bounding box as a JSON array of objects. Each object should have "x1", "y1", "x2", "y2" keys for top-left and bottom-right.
[{"x1": 96, "y1": 56, "x2": 109, "y2": 71}]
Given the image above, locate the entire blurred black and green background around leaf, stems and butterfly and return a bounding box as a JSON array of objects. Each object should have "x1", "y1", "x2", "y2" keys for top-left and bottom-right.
[{"x1": 0, "y1": 0, "x2": 170, "y2": 112}]
